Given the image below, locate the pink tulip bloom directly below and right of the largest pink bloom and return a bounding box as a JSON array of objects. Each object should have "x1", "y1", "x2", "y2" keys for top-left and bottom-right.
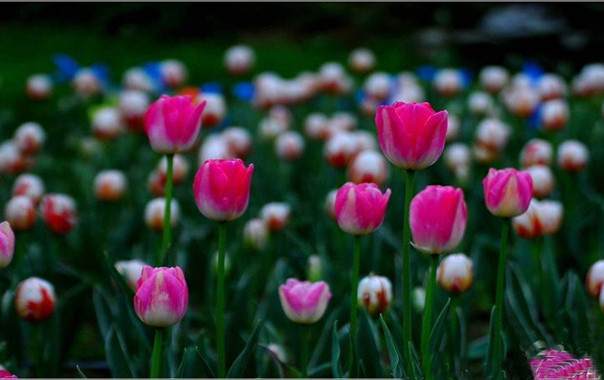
[{"x1": 409, "y1": 186, "x2": 468, "y2": 254}]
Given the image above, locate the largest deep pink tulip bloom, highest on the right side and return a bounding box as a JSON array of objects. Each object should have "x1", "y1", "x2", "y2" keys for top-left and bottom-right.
[{"x1": 375, "y1": 102, "x2": 447, "y2": 170}]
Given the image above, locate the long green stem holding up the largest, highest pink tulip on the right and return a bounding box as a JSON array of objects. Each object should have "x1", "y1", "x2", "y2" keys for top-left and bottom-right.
[{"x1": 402, "y1": 170, "x2": 415, "y2": 378}]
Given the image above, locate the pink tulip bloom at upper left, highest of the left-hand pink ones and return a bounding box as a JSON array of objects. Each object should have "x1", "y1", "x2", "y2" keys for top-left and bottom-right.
[{"x1": 145, "y1": 95, "x2": 205, "y2": 154}]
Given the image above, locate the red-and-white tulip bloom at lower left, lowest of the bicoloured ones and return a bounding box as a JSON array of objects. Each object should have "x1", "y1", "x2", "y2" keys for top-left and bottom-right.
[{"x1": 15, "y1": 277, "x2": 56, "y2": 322}]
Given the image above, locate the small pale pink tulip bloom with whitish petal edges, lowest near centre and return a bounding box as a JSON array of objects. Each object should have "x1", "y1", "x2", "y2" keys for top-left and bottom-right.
[{"x1": 279, "y1": 278, "x2": 331, "y2": 324}]
